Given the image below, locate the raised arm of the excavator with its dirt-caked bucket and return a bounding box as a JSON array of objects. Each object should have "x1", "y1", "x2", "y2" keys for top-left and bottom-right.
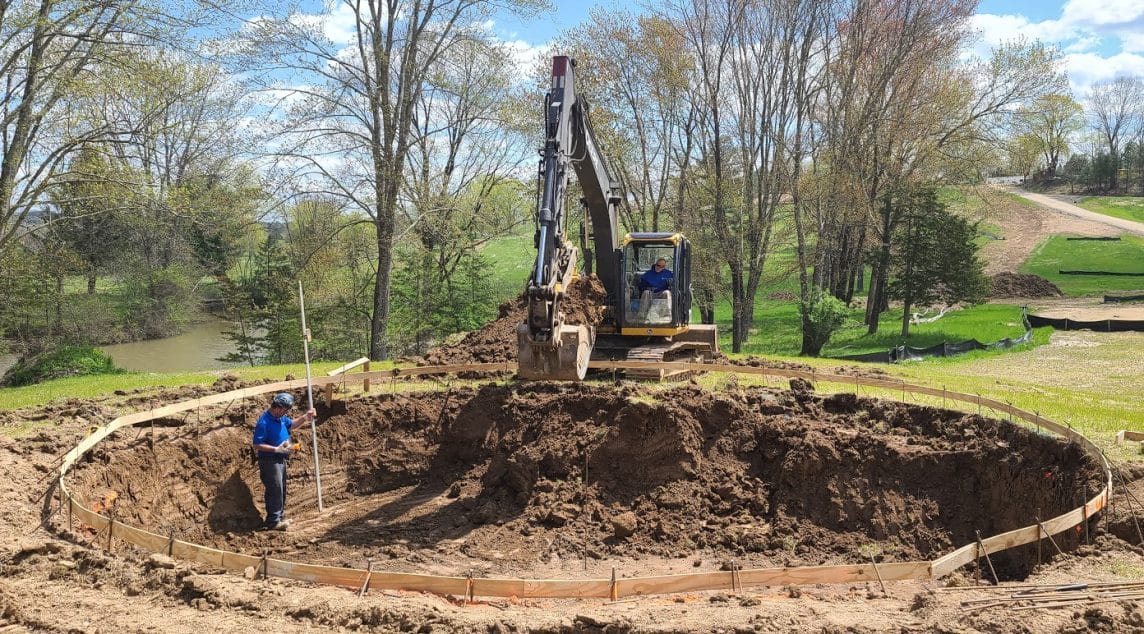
[{"x1": 517, "y1": 56, "x2": 620, "y2": 381}]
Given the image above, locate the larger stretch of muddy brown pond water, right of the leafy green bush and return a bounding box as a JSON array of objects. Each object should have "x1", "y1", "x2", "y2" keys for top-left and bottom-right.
[{"x1": 99, "y1": 319, "x2": 239, "y2": 372}]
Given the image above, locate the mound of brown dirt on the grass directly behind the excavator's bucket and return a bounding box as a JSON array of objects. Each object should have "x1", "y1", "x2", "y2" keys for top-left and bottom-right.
[{"x1": 420, "y1": 276, "x2": 607, "y2": 365}]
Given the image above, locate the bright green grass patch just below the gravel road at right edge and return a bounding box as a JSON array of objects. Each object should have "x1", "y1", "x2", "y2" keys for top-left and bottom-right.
[{"x1": 1020, "y1": 233, "x2": 1144, "y2": 296}]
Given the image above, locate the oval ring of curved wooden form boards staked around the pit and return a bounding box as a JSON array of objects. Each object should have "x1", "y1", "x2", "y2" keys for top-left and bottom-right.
[{"x1": 57, "y1": 362, "x2": 1112, "y2": 600}]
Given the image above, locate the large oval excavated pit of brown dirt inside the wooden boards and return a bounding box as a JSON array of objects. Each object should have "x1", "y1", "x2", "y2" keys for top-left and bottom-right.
[{"x1": 66, "y1": 380, "x2": 1101, "y2": 579}]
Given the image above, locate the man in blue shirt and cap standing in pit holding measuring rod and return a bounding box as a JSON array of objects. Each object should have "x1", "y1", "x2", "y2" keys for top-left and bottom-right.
[{"x1": 253, "y1": 391, "x2": 318, "y2": 531}]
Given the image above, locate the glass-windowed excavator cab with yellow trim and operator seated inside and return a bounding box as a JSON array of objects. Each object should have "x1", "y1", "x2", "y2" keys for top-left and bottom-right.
[{"x1": 619, "y1": 233, "x2": 691, "y2": 329}]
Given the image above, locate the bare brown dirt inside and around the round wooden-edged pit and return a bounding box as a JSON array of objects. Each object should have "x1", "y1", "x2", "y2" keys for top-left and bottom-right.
[{"x1": 0, "y1": 375, "x2": 1144, "y2": 633}]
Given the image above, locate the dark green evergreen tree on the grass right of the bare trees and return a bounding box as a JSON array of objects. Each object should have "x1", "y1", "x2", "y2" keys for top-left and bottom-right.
[{"x1": 889, "y1": 188, "x2": 988, "y2": 339}]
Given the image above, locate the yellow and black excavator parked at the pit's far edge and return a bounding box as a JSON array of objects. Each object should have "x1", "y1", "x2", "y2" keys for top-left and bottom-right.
[{"x1": 517, "y1": 56, "x2": 718, "y2": 381}]
